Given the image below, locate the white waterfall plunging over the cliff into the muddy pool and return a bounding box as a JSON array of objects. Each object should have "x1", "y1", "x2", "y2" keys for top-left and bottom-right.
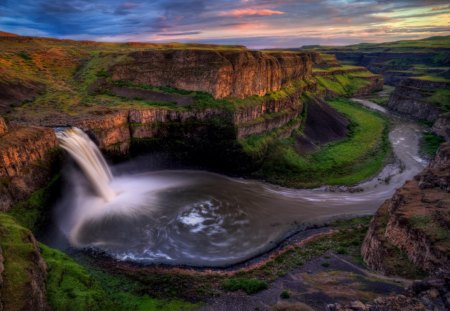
[{"x1": 56, "y1": 127, "x2": 116, "y2": 202}]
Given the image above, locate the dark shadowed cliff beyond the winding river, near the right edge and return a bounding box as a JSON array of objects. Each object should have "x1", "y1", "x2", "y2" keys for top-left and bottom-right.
[{"x1": 388, "y1": 79, "x2": 450, "y2": 122}]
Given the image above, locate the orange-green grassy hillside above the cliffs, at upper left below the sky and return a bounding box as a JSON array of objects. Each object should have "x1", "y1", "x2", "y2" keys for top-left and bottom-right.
[{"x1": 0, "y1": 34, "x2": 246, "y2": 120}]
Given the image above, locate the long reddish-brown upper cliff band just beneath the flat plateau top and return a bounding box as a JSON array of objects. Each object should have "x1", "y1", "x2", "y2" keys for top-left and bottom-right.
[{"x1": 110, "y1": 50, "x2": 314, "y2": 98}]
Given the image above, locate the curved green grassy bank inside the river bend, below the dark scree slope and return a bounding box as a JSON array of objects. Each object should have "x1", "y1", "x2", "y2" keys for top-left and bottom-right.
[{"x1": 258, "y1": 99, "x2": 389, "y2": 187}]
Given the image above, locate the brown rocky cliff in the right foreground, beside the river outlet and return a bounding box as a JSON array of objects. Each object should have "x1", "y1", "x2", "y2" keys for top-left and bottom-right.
[{"x1": 362, "y1": 143, "x2": 450, "y2": 274}]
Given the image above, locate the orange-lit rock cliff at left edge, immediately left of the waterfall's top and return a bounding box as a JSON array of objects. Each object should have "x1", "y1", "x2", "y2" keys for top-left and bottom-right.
[{"x1": 0, "y1": 127, "x2": 57, "y2": 211}]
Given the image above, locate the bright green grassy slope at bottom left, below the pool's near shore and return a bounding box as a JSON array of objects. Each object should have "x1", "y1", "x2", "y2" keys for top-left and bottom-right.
[{"x1": 41, "y1": 245, "x2": 198, "y2": 311}]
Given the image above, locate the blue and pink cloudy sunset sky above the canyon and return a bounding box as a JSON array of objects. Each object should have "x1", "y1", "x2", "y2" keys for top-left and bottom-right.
[{"x1": 0, "y1": 0, "x2": 450, "y2": 49}]
